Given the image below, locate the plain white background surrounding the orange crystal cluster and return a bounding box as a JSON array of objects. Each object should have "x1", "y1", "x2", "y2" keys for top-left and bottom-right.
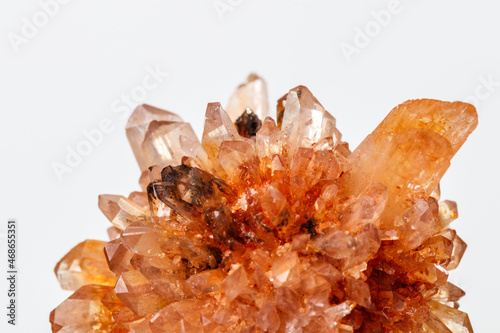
[{"x1": 0, "y1": 0, "x2": 500, "y2": 333}]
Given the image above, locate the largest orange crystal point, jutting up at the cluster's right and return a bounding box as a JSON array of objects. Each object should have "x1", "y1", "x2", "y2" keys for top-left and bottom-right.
[{"x1": 342, "y1": 100, "x2": 477, "y2": 235}]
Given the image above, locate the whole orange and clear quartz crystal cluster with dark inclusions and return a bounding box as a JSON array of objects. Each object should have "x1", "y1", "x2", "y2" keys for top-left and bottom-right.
[{"x1": 50, "y1": 75, "x2": 477, "y2": 333}]
